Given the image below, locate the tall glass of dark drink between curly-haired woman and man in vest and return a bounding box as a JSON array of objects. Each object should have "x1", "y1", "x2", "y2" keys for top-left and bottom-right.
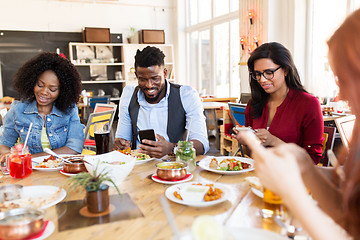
[{"x1": 94, "y1": 122, "x2": 110, "y2": 155}]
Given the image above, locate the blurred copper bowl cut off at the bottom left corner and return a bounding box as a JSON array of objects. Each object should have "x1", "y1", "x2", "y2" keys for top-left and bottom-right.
[{"x1": 0, "y1": 208, "x2": 45, "y2": 240}]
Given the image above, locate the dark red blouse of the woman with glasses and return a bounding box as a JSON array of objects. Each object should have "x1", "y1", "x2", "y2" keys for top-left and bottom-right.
[{"x1": 245, "y1": 89, "x2": 324, "y2": 164}]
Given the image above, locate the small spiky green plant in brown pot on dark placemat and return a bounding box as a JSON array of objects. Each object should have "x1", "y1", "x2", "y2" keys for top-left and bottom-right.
[{"x1": 69, "y1": 165, "x2": 120, "y2": 213}]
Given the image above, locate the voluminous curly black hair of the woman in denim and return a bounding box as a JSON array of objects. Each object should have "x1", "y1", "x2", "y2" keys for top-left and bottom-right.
[{"x1": 14, "y1": 52, "x2": 82, "y2": 112}]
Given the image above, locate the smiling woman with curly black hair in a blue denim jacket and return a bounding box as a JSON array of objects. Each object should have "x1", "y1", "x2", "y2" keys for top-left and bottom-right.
[{"x1": 0, "y1": 52, "x2": 84, "y2": 157}]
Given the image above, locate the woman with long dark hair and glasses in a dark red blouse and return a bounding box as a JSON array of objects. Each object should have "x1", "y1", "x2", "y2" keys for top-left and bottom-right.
[{"x1": 236, "y1": 42, "x2": 324, "y2": 163}]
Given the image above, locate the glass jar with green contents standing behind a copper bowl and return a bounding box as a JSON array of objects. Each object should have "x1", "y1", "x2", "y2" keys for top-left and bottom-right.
[{"x1": 175, "y1": 141, "x2": 196, "y2": 172}]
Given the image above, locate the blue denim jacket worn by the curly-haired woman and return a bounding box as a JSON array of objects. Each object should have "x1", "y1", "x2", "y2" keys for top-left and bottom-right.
[{"x1": 0, "y1": 101, "x2": 85, "y2": 154}]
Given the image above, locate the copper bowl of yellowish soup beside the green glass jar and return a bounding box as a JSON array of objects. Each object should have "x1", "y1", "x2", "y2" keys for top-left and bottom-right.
[{"x1": 155, "y1": 162, "x2": 187, "y2": 181}]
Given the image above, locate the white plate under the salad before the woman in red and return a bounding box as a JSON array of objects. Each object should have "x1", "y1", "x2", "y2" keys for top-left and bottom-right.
[{"x1": 199, "y1": 156, "x2": 254, "y2": 175}]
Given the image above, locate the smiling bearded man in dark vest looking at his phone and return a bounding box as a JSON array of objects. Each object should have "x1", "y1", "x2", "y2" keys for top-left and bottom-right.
[{"x1": 114, "y1": 46, "x2": 209, "y2": 158}]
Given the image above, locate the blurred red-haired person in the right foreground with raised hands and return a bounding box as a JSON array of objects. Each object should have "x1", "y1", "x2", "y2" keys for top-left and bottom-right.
[{"x1": 240, "y1": 10, "x2": 360, "y2": 239}]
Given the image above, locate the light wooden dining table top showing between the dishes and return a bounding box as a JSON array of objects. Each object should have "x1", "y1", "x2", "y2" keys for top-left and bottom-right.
[{"x1": 0, "y1": 156, "x2": 296, "y2": 240}]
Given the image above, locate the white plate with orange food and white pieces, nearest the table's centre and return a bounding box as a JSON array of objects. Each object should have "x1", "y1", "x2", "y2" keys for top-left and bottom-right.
[{"x1": 165, "y1": 182, "x2": 230, "y2": 207}]
